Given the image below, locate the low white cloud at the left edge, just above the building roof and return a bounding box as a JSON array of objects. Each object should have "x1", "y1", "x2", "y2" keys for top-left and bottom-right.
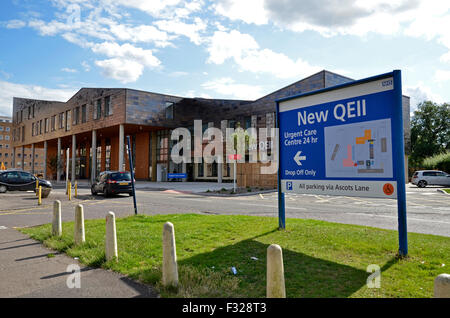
[{"x1": 0, "y1": 81, "x2": 78, "y2": 116}]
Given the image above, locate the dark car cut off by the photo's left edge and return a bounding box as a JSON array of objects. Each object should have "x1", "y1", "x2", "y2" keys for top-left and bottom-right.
[{"x1": 0, "y1": 170, "x2": 52, "y2": 198}]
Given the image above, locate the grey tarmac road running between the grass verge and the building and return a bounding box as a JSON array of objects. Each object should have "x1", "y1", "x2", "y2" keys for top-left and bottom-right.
[{"x1": 0, "y1": 184, "x2": 450, "y2": 236}]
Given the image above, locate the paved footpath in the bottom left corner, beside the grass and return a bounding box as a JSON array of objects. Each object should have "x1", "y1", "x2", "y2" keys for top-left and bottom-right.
[{"x1": 0, "y1": 226, "x2": 158, "y2": 298}]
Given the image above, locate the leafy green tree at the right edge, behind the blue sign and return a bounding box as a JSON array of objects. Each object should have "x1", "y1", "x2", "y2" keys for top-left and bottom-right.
[{"x1": 410, "y1": 101, "x2": 450, "y2": 167}]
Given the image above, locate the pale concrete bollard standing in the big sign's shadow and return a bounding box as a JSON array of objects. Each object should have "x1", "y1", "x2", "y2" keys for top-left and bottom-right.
[{"x1": 267, "y1": 244, "x2": 286, "y2": 298}]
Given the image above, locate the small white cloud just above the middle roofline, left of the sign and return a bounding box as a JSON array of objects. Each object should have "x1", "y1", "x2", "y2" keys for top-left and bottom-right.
[{"x1": 202, "y1": 77, "x2": 264, "y2": 100}]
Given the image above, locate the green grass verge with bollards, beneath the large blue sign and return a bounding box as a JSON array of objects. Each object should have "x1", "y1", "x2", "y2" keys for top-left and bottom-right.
[{"x1": 21, "y1": 214, "x2": 450, "y2": 297}]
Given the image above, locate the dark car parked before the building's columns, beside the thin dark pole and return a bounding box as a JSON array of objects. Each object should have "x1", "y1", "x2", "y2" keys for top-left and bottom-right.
[{"x1": 91, "y1": 171, "x2": 133, "y2": 197}]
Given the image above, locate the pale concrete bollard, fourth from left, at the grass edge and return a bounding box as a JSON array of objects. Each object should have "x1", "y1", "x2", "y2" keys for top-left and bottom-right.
[{"x1": 162, "y1": 222, "x2": 178, "y2": 287}]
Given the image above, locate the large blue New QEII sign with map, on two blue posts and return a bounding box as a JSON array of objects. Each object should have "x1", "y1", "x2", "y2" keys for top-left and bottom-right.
[{"x1": 277, "y1": 71, "x2": 407, "y2": 255}]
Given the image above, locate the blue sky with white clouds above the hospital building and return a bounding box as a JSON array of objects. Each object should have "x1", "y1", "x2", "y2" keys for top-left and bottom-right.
[{"x1": 0, "y1": 0, "x2": 450, "y2": 115}]
